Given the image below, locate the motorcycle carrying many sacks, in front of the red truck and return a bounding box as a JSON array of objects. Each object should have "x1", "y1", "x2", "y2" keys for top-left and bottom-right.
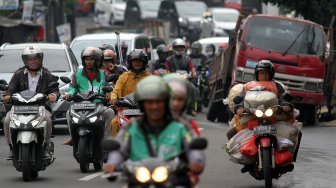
[{"x1": 234, "y1": 90, "x2": 300, "y2": 188}]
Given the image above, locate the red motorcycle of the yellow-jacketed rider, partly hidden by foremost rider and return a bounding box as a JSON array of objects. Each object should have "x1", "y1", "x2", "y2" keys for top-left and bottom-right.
[{"x1": 115, "y1": 93, "x2": 143, "y2": 129}]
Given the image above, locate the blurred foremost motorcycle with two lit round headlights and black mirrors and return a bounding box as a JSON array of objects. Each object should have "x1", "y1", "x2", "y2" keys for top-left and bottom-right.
[{"x1": 102, "y1": 138, "x2": 207, "y2": 188}]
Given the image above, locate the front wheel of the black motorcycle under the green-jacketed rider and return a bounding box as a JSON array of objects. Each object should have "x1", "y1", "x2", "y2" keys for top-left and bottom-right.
[{"x1": 78, "y1": 136, "x2": 90, "y2": 173}]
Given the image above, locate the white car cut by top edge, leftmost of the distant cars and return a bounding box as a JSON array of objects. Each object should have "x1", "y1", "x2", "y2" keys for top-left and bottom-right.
[{"x1": 93, "y1": 0, "x2": 126, "y2": 26}]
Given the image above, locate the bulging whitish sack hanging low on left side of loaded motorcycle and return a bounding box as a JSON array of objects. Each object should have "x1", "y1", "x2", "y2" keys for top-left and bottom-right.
[{"x1": 224, "y1": 129, "x2": 257, "y2": 164}]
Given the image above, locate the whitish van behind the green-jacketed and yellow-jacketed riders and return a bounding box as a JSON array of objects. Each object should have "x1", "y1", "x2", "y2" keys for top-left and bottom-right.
[{"x1": 70, "y1": 32, "x2": 154, "y2": 62}]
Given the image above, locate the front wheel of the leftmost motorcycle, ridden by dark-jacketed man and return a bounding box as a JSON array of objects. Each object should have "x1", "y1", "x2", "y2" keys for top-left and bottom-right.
[{"x1": 21, "y1": 144, "x2": 32, "y2": 181}]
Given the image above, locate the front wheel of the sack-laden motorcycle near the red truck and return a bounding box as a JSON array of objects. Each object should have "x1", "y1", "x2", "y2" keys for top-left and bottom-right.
[{"x1": 261, "y1": 148, "x2": 272, "y2": 188}]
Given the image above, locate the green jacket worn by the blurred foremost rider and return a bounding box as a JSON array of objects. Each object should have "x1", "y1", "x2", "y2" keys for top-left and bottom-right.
[{"x1": 124, "y1": 121, "x2": 191, "y2": 161}]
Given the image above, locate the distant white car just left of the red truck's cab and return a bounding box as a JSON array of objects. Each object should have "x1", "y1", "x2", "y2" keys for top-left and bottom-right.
[{"x1": 201, "y1": 8, "x2": 239, "y2": 37}]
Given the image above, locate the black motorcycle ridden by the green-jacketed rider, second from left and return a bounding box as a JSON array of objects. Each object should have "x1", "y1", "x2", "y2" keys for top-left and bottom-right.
[{"x1": 61, "y1": 77, "x2": 112, "y2": 173}]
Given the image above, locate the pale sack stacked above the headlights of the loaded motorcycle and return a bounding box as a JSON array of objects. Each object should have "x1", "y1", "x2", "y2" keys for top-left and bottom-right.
[{"x1": 244, "y1": 91, "x2": 278, "y2": 109}]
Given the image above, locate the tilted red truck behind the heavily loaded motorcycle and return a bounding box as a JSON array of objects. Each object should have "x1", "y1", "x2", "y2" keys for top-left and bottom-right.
[{"x1": 209, "y1": 15, "x2": 333, "y2": 124}]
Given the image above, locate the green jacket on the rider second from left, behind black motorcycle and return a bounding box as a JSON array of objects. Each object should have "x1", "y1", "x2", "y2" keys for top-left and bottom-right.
[{"x1": 69, "y1": 69, "x2": 105, "y2": 100}]
